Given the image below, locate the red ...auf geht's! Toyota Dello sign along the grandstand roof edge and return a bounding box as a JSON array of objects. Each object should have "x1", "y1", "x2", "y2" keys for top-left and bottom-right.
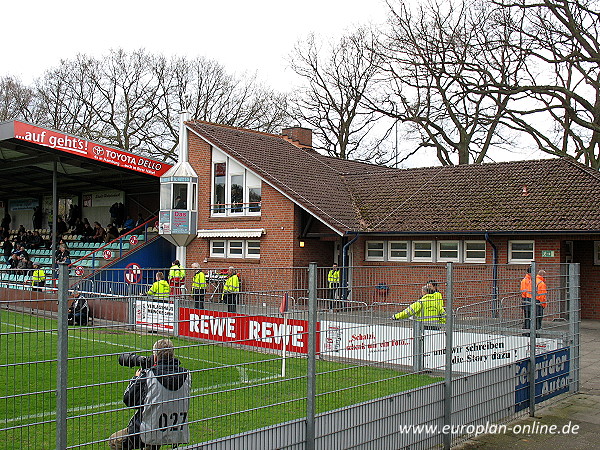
[{"x1": 14, "y1": 121, "x2": 171, "y2": 177}]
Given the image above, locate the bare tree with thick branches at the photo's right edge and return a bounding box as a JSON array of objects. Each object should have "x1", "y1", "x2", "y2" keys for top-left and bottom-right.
[{"x1": 498, "y1": 0, "x2": 600, "y2": 169}]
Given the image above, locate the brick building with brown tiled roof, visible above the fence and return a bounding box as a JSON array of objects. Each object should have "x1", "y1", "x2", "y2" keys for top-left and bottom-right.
[{"x1": 180, "y1": 121, "x2": 600, "y2": 319}]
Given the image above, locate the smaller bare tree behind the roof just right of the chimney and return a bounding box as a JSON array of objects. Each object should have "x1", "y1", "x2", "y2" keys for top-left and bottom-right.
[{"x1": 290, "y1": 29, "x2": 389, "y2": 163}]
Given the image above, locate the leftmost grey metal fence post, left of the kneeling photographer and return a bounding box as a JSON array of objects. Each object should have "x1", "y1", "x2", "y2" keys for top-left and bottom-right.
[{"x1": 56, "y1": 263, "x2": 69, "y2": 450}]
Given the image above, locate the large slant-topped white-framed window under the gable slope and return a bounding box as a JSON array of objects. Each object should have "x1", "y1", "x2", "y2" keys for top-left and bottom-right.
[{"x1": 211, "y1": 149, "x2": 262, "y2": 216}]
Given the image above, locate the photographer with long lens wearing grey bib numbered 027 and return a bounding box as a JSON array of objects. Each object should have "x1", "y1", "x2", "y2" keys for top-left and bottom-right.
[{"x1": 109, "y1": 339, "x2": 191, "y2": 450}]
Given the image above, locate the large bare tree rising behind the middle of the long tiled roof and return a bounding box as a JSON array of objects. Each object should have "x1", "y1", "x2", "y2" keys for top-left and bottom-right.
[{"x1": 370, "y1": 0, "x2": 523, "y2": 165}]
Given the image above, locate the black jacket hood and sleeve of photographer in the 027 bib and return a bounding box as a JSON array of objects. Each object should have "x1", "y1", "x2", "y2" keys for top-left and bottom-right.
[{"x1": 123, "y1": 358, "x2": 189, "y2": 443}]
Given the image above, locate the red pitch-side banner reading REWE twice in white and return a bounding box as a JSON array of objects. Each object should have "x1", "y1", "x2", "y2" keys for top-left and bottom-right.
[{"x1": 179, "y1": 308, "x2": 319, "y2": 353}]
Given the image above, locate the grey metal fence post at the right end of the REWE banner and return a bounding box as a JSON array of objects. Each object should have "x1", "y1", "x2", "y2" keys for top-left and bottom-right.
[{"x1": 305, "y1": 263, "x2": 317, "y2": 450}]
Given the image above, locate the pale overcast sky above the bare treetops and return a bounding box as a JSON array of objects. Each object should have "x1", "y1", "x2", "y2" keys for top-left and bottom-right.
[{"x1": 0, "y1": 0, "x2": 387, "y2": 90}]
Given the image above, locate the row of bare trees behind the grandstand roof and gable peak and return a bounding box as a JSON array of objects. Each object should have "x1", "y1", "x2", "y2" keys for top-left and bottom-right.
[{"x1": 28, "y1": 50, "x2": 287, "y2": 161}]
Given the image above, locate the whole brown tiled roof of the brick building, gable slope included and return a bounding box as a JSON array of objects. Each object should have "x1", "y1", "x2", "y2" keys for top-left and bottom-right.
[{"x1": 188, "y1": 121, "x2": 600, "y2": 233}]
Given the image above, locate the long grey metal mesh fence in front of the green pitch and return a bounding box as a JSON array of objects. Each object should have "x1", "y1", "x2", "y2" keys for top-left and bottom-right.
[{"x1": 0, "y1": 263, "x2": 579, "y2": 449}]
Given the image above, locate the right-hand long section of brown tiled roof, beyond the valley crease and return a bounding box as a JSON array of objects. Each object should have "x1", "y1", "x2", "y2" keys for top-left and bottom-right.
[{"x1": 348, "y1": 159, "x2": 600, "y2": 232}]
